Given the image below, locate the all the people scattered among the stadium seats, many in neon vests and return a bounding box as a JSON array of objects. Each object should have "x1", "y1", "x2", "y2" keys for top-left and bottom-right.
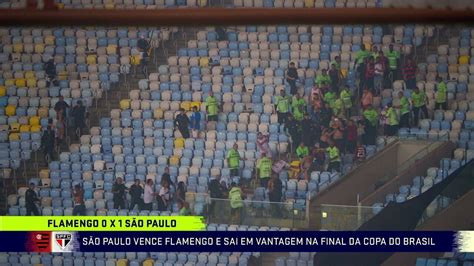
[{"x1": 27, "y1": 38, "x2": 447, "y2": 220}]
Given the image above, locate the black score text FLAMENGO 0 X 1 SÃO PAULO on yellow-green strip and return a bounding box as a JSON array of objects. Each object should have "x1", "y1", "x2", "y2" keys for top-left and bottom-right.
[{"x1": 48, "y1": 218, "x2": 176, "y2": 229}]
